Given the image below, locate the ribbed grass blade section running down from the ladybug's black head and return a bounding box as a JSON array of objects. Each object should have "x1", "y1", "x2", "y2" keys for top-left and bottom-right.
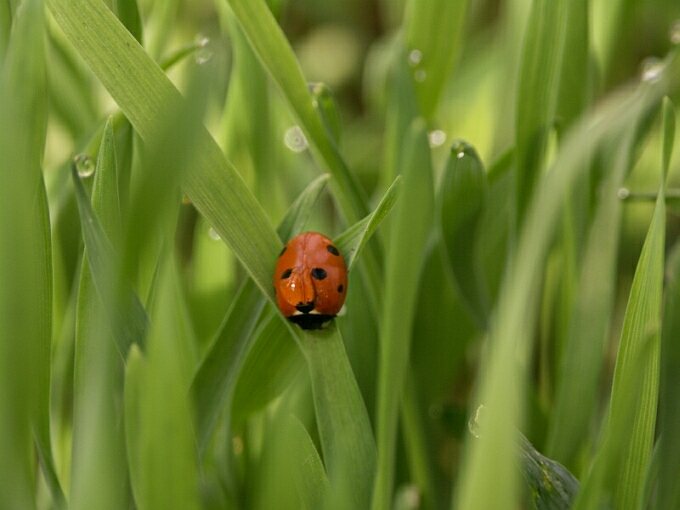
[{"x1": 296, "y1": 323, "x2": 376, "y2": 508}]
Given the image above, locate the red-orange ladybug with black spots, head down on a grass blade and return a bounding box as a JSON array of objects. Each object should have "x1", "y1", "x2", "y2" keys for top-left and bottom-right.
[{"x1": 274, "y1": 232, "x2": 347, "y2": 329}]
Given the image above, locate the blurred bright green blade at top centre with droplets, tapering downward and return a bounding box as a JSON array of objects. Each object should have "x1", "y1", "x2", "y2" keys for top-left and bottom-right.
[{"x1": 405, "y1": 0, "x2": 468, "y2": 119}]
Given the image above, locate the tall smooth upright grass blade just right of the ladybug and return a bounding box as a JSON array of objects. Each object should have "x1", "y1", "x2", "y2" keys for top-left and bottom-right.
[{"x1": 373, "y1": 121, "x2": 434, "y2": 510}]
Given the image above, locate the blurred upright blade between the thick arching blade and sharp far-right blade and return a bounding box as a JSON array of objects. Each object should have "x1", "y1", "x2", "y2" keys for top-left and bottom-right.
[{"x1": 548, "y1": 136, "x2": 632, "y2": 466}]
